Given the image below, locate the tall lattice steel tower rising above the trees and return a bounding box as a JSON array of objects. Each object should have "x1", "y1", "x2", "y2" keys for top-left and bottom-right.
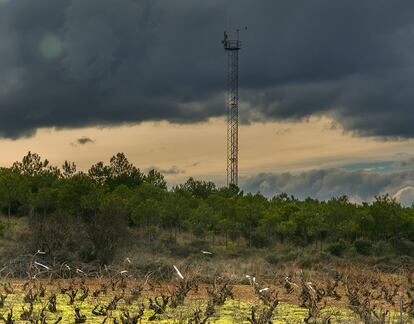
[{"x1": 222, "y1": 29, "x2": 241, "y2": 186}]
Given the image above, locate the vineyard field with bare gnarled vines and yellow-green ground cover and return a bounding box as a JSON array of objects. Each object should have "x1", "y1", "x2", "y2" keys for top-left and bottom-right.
[{"x1": 0, "y1": 263, "x2": 414, "y2": 324}]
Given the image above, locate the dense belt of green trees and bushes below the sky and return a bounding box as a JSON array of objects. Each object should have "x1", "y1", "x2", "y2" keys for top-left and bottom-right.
[{"x1": 0, "y1": 152, "x2": 414, "y2": 263}]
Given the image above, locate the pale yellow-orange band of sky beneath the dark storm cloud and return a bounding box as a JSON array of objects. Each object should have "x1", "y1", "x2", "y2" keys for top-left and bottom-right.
[{"x1": 0, "y1": 117, "x2": 414, "y2": 183}]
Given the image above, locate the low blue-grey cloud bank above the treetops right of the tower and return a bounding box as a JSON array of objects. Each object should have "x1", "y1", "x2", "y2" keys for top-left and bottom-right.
[{"x1": 241, "y1": 169, "x2": 414, "y2": 202}]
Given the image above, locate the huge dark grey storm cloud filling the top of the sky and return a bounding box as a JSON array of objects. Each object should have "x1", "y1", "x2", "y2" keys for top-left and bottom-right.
[{"x1": 0, "y1": 0, "x2": 414, "y2": 138}]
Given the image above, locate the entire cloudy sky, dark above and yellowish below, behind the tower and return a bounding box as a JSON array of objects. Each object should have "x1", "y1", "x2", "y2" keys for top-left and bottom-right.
[{"x1": 0, "y1": 0, "x2": 414, "y2": 205}]
